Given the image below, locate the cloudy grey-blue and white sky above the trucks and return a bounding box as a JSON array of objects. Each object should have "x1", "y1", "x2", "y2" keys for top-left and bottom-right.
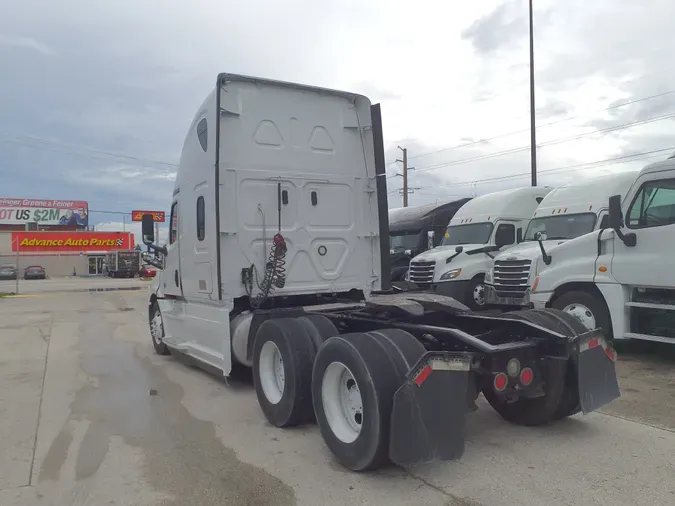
[{"x1": 0, "y1": 0, "x2": 675, "y2": 239}]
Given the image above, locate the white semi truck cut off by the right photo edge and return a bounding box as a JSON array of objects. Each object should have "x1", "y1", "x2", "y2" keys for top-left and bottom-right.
[{"x1": 512, "y1": 157, "x2": 675, "y2": 343}]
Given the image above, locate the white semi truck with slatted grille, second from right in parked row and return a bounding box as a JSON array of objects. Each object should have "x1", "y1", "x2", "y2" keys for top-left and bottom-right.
[{"x1": 485, "y1": 171, "x2": 637, "y2": 308}]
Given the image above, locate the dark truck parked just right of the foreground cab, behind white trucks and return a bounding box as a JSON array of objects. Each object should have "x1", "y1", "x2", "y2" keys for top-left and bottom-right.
[{"x1": 389, "y1": 198, "x2": 471, "y2": 281}]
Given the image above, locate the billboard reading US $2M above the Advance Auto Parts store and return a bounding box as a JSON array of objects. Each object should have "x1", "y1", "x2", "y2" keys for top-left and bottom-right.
[{"x1": 0, "y1": 198, "x2": 89, "y2": 227}]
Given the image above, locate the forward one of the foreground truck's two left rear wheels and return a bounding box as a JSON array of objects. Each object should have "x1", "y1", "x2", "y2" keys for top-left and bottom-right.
[{"x1": 253, "y1": 318, "x2": 316, "y2": 427}]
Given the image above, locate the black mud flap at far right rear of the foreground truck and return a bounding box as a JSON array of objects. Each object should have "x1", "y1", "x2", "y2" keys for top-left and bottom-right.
[{"x1": 576, "y1": 330, "x2": 621, "y2": 414}]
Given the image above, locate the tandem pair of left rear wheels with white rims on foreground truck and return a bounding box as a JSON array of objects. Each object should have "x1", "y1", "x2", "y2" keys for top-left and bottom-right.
[{"x1": 253, "y1": 315, "x2": 425, "y2": 471}]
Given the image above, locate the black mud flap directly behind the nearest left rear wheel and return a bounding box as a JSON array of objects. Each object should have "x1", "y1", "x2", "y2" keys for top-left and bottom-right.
[{"x1": 389, "y1": 352, "x2": 472, "y2": 466}]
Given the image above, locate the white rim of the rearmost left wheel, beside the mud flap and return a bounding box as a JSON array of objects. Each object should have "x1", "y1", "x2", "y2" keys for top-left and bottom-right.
[{"x1": 321, "y1": 362, "x2": 363, "y2": 443}]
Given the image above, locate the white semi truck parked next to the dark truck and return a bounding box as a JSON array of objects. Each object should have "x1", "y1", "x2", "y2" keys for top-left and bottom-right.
[{"x1": 408, "y1": 187, "x2": 551, "y2": 310}]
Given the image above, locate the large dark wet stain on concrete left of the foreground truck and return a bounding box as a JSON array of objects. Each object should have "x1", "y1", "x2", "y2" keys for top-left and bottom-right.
[{"x1": 39, "y1": 301, "x2": 296, "y2": 506}]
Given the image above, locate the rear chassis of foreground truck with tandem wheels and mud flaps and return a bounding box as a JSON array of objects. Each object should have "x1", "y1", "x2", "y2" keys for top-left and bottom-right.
[{"x1": 250, "y1": 293, "x2": 620, "y2": 471}]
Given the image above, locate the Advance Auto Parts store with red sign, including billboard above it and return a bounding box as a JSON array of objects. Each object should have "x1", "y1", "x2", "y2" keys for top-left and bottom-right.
[{"x1": 0, "y1": 198, "x2": 135, "y2": 277}]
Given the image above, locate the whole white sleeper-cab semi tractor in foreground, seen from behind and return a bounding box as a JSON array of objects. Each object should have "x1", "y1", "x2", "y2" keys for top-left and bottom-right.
[{"x1": 142, "y1": 74, "x2": 619, "y2": 471}]
